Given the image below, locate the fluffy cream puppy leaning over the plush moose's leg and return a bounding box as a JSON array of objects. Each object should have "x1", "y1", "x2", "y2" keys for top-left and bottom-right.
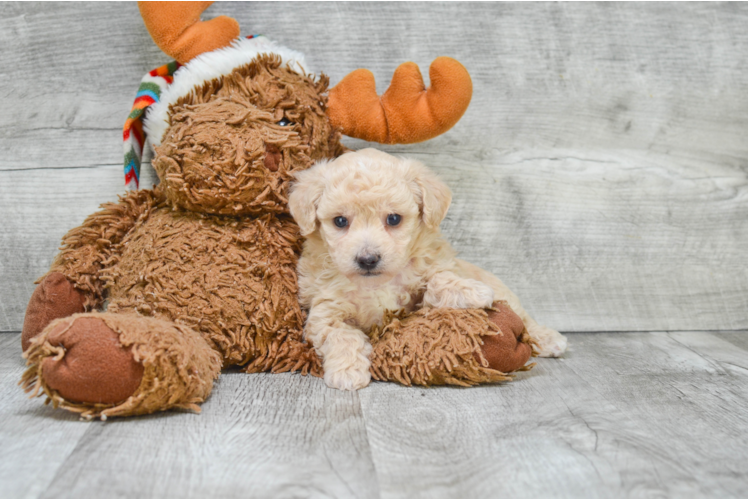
[{"x1": 289, "y1": 149, "x2": 566, "y2": 390}]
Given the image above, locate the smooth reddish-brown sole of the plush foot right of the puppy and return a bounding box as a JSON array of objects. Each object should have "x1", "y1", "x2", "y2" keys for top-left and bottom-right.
[{"x1": 481, "y1": 301, "x2": 532, "y2": 373}]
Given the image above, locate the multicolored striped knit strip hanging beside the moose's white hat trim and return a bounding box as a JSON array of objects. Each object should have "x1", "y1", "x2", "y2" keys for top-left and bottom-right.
[{"x1": 122, "y1": 61, "x2": 182, "y2": 189}]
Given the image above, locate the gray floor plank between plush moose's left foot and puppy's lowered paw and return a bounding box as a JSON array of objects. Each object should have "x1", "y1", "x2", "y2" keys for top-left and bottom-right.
[{"x1": 41, "y1": 373, "x2": 379, "y2": 498}]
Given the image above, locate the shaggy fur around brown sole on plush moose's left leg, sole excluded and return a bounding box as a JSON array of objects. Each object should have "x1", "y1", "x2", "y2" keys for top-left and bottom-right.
[{"x1": 21, "y1": 313, "x2": 221, "y2": 419}]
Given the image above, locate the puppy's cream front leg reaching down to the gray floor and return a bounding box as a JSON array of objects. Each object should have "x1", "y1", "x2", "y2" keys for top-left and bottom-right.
[{"x1": 304, "y1": 303, "x2": 371, "y2": 391}]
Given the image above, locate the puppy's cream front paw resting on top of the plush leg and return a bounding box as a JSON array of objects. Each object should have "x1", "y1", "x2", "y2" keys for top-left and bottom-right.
[{"x1": 423, "y1": 271, "x2": 494, "y2": 309}]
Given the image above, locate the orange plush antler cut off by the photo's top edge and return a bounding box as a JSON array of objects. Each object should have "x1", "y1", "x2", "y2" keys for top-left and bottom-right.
[{"x1": 138, "y1": 2, "x2": 239, "y2": 63}]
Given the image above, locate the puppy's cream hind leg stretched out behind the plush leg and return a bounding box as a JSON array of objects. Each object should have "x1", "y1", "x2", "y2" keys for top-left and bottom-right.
[{"x1": 457, "y1": 259, "x2": 567, "y2": 358}]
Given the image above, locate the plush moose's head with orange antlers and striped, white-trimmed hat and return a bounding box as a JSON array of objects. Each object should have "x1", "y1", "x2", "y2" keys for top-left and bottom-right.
[{"x1": 125, "y1": 2, "x2": 472, "y2": 193}]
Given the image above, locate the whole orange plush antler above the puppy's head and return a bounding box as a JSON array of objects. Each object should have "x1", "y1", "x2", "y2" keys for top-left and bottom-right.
[{"x1": 327, "y1": 57, "x2": 473, "y2": 144}]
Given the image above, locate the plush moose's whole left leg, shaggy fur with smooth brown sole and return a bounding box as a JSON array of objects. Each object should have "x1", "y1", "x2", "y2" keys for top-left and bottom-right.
[{"x1": 22, "y1": 313, "x2": 221, "y2": 418}]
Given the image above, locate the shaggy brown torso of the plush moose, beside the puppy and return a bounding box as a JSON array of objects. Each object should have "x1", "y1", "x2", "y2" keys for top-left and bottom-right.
[{"x1": 100, "y1": 207, "x2": 319, "y2": 372}]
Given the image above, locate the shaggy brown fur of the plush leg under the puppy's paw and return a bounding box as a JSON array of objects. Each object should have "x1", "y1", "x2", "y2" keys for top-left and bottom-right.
[{"x1": 369, "y1": 308, "x2": 529, "y2": 386}]
